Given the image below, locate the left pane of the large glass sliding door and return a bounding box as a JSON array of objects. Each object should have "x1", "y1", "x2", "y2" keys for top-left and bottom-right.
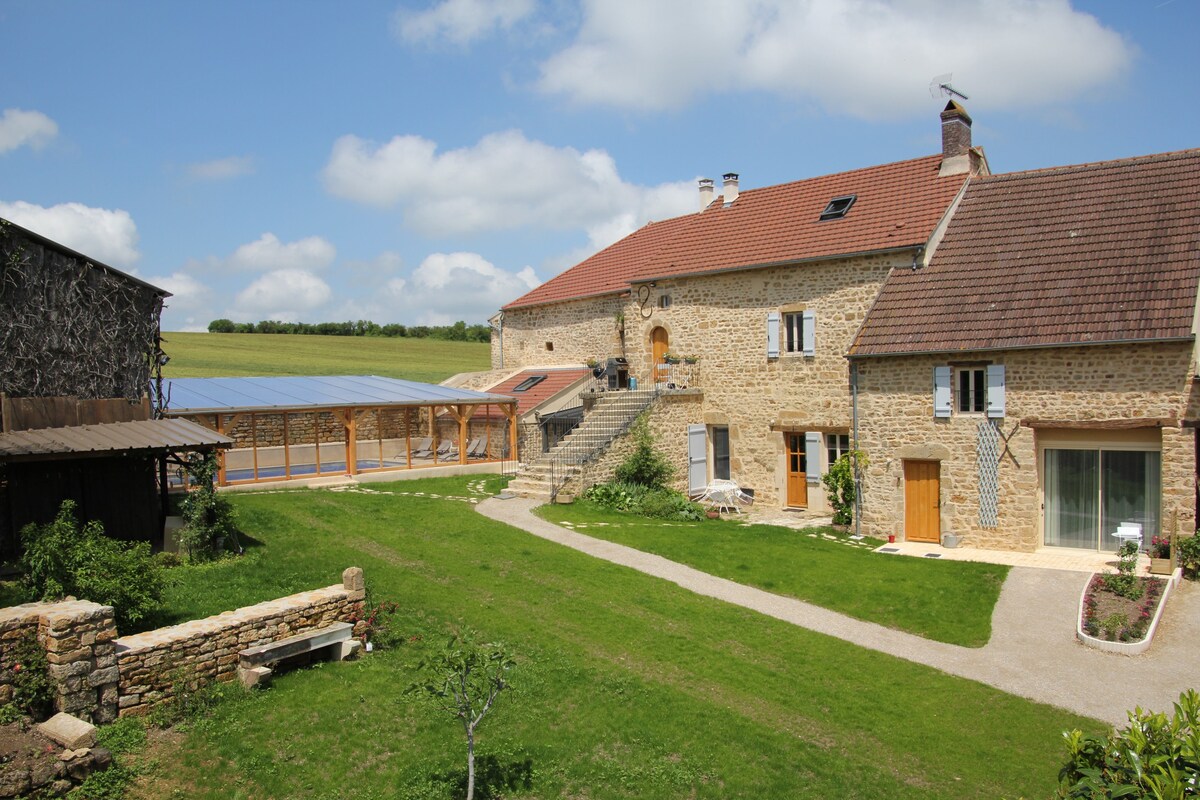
[{"x1": 1045, "y1": 450, "x2": 1100, "y2": 549}]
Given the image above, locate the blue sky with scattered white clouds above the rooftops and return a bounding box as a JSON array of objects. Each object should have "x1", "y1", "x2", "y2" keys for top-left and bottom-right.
[{"x1": 0, "y1": 0, "x2": 1200, "y2": 330}]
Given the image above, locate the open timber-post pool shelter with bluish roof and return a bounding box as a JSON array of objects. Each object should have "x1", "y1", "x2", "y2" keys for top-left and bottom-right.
[{"x1": 163, "y1": 375, "x2": 517, "y2": 486}]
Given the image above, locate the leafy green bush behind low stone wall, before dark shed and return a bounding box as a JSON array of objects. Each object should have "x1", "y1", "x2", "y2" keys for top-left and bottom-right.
[{"x1": 20, "y1": 500, "x2": 166, "y2": 627}]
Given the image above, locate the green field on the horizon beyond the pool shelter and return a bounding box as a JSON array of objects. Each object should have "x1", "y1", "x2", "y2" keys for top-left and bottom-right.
[{"x1": 162, "y1": 333, "x2": 491, "y2": 384}]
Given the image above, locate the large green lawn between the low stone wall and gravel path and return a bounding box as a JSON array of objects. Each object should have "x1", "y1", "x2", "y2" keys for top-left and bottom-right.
[{"x1": 124, "y1": 477, "x2": 1103, "y2": 800}]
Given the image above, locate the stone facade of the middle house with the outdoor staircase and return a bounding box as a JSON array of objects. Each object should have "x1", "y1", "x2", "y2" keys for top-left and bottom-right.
[{"x1": 493, "y1": 252, "x2": 912, "y2": 513}]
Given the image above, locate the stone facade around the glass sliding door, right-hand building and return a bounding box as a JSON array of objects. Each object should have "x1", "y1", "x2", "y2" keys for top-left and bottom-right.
[{"x1": 858, "y1": 343, "x2": 1196, "y2": 551}]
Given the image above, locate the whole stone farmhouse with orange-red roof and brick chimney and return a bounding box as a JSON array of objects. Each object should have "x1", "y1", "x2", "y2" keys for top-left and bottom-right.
[{"x1": 492, "y1": 103, "x2": 988, "y2": 513}]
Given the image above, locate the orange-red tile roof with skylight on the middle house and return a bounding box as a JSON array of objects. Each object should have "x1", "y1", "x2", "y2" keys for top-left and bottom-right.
[{"x1": 504, "y1": 155, "x2": 966, "y2": 308}]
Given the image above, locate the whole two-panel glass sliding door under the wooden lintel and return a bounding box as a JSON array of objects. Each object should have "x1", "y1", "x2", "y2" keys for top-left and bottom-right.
[{"x1": 1044, "y1": 449, "x2": 1162, "y2": 551}]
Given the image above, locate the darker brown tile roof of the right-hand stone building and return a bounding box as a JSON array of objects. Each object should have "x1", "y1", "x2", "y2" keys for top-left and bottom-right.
[{"x1": 851, "y1": 150, "x2": 1200, "y2": 356}]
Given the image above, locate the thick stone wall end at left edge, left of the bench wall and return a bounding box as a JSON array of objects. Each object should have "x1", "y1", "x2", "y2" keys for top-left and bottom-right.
[{"x1": 0, "y1": 600, "x2": 118, "y2": 723}]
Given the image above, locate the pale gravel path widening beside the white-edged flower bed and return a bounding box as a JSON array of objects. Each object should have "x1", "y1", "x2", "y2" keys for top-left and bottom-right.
[{"x1": 475, "y1": 498, "x2": 1200, "y2": 724}]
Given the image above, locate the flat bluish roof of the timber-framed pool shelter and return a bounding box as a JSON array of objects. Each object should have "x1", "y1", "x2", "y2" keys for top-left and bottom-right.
[{"x1": 163, "y1": 375, "x2": 514, "y2": 416}]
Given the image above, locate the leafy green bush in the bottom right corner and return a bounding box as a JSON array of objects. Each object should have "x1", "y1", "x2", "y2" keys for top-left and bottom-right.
[{"x1": 1056, "y1": 688, "x2": 1200, "y2": 800}]
